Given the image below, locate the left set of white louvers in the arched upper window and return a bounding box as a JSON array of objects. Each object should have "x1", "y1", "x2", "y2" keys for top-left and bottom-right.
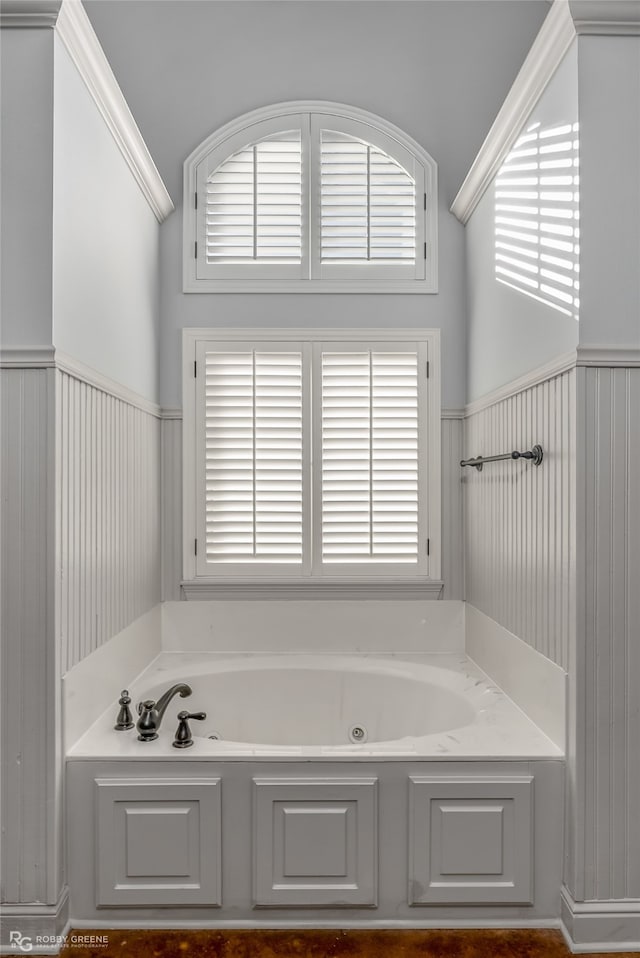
[{"x1": 206, "y1": 130, "x2": 302, "y2": 265}]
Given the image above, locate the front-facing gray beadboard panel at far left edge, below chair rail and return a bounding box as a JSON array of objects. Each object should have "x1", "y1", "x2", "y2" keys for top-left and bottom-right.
[{"x1": 0, "y1": 368, "x2": 61, "y2": 904}]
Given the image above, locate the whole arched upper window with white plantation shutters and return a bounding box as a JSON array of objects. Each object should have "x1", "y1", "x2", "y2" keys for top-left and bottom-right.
[{"x1": 184, "y1": 103, "x2": 437, "y2": 293}]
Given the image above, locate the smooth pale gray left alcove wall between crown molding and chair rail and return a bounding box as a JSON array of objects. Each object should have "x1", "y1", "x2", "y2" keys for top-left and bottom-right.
[{"x1": 53, "y1": 36, "x2": 159, "y2": 401}]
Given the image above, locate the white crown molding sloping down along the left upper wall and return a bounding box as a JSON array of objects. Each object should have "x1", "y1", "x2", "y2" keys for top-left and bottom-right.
[{"x1": 56, "y1": 0, "x2": 174, "y2": 223}]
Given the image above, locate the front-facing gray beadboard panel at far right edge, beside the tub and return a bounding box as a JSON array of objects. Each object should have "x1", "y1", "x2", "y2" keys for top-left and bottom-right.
[{"x1": 568, "y1": 367, "x2": 640, "y2": 903}]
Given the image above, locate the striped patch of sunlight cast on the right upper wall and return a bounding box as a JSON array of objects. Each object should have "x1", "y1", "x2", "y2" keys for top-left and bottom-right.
[{"x1": 495, "y1": 123, "x2": 580, "y2": 319}]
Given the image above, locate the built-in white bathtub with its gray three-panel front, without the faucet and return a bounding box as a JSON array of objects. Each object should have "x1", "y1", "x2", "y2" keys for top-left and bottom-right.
[{"x1": 66, "y1": 652, "x2": 563, "y2": 928}]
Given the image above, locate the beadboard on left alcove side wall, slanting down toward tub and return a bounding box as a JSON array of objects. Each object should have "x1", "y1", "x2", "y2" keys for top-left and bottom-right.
[{"x1": 56, "y1": 370, "x2": 160, "y2": 674}]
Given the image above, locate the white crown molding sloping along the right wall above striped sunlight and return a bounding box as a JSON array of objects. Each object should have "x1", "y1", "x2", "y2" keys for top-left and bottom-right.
[{"x1": 451, "y1": 0, "x2": 576, "y2": 224}]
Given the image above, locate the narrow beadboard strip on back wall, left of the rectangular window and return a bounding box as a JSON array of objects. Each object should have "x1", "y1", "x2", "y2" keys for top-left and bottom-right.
[{"x1": 161, "y1": 412, "x2": 182, "y2": 602}]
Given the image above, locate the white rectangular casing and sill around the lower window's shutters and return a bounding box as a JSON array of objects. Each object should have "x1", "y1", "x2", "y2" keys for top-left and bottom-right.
[{"x1": 182, "y1": 328, "x2": 441, "y2": 598}]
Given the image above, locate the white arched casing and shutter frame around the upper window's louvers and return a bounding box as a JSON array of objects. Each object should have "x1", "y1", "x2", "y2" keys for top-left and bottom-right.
[{"x1": 183, "y1": 100, "x2": 438, "y2": 293}]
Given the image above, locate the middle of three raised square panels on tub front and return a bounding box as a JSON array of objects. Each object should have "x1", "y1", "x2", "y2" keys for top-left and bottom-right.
[{"x1": 253, "y1": 778, "x2": 378, "y2": 908}]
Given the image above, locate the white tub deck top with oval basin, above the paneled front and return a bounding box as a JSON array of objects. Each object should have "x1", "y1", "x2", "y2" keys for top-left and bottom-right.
[{"x1": 68, "y1": 652, "x2": 562, "y2": 762}]
